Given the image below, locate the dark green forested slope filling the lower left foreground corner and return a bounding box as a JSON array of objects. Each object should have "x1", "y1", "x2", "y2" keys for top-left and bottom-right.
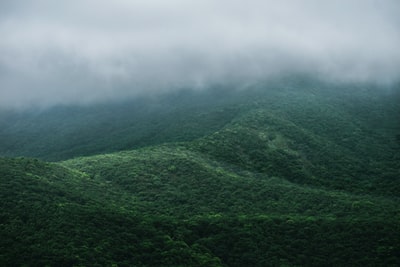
[{"x1": 0, "y1": 159, "x2": 220, "y2": 266}]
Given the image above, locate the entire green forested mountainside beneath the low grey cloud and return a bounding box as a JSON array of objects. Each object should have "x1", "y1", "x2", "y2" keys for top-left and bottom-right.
[{"x1": 0, "y1": 77, "x2": 400, "y2": 266}]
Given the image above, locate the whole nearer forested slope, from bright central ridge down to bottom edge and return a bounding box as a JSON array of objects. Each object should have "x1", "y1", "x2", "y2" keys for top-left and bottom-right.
[{"x1": 0, "y1": 145, "x2": 400, "y2": 266}]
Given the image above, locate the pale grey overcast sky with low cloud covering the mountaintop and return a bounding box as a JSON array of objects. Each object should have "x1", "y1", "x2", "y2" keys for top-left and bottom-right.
[{"x1": 0, "y1": 0, "x2": 400, "y2": 107}]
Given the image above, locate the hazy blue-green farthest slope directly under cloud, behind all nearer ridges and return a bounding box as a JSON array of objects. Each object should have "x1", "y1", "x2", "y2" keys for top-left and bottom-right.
[{"x1": 0, "y1": 78, "x2": 400, "y2": 161}]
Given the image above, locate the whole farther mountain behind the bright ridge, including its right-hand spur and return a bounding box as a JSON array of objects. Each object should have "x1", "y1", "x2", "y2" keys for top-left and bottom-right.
[{"x1": 0, "y1": 77, "x2": 400, "y2": 195}]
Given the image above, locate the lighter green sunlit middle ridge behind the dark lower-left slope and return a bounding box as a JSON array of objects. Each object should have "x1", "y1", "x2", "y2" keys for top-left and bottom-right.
[{"x1": 63, "y1": 145, "x2": 396, "y2": 218}]
